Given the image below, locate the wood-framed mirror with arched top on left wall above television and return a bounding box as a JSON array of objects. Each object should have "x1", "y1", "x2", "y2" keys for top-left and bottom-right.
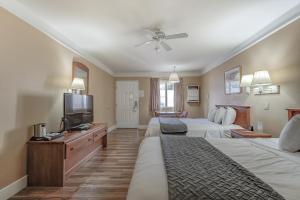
[{"x1": 72, "y1": 62, "x2": 89, "y2": 94}]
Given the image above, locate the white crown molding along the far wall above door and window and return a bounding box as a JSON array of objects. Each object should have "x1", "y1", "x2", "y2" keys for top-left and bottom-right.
[{"x1": 114, "y1": 71, "x2": 202, "y2": 78}]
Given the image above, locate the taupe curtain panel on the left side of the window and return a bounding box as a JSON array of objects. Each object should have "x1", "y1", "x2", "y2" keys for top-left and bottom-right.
[{"x1": 150, "y1": 78, "x2": 160, "y2": 112}]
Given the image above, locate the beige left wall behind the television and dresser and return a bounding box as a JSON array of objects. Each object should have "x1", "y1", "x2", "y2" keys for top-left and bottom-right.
[{"x1": 0, "y1": 8, "x2": 115, "y2": 188}]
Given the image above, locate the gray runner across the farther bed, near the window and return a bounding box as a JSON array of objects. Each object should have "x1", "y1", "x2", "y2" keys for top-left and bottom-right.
[{"x1": 159, "y1": 117, "x2": 187, "y2": 135}]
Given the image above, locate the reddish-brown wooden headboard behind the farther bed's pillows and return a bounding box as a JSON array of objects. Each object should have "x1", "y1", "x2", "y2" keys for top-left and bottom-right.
[{"x1": 216, "y1": 105, "x2": 250, "y2": 129}]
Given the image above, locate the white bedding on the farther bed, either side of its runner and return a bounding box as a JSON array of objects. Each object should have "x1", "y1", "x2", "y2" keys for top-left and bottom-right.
[{"x1": 145, "y1": 117, "x2": 242, "y2": 138}]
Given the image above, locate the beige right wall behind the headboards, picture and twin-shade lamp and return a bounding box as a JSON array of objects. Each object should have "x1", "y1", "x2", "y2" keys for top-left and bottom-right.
[{"x1": 201, "y1": 20, "x2": 300, "y2": 136}]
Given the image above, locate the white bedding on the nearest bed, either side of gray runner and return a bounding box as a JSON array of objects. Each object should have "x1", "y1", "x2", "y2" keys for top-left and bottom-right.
[{"x1": 127, "y1": 137, "x2": 300, "y2": 200}]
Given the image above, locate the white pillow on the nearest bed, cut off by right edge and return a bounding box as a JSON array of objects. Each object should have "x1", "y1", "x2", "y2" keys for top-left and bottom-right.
[{"x1": 279, "y1": 115, "x2": 300, "y2": 152}]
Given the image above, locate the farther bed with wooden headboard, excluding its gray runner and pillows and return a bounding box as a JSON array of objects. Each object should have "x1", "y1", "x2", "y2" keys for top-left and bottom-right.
[{"x1": 145, "y1": 105, "x2": 250, "y2": 138}]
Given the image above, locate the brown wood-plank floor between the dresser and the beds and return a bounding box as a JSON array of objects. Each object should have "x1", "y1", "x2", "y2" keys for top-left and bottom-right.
[{"x1": 11, "y1": 129, "x2": 144, "y2": 200}]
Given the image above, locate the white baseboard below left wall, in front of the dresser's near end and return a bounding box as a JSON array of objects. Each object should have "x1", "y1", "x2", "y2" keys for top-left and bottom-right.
[{"x1": 0, "y1": 175, "x2": 27, "y2": 200}]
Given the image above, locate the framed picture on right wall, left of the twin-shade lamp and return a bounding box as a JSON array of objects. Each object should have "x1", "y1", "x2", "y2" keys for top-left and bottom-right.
[{"x1": 224, "y1": 66, "x2": 242, "y2": 95}]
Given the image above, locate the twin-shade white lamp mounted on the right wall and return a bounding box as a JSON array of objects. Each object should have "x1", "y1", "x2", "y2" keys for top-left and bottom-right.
[{"x1": 240, "y1": 71, "x2": 280, "y2": 95}]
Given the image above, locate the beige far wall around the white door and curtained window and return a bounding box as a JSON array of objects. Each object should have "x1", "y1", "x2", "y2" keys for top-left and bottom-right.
[{"x1": 115, "y1": 77, "x2": 201, "y2": 125}]
